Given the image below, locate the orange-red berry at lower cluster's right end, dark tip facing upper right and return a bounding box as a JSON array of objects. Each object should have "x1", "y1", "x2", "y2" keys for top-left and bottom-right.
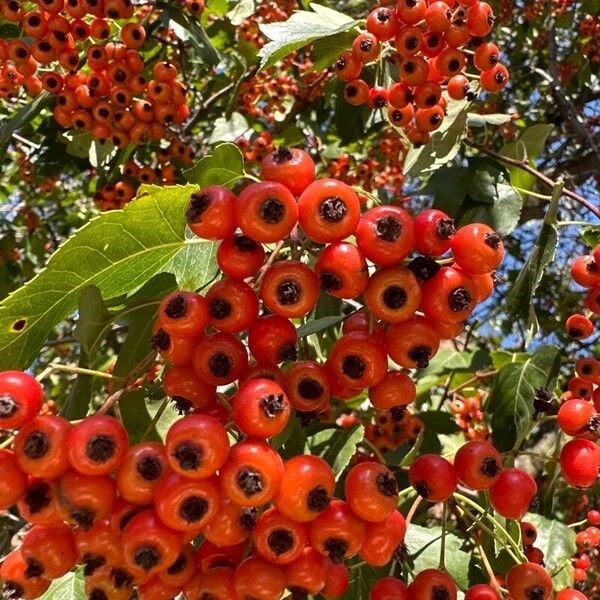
[{"x1": 344, "y1": 462, "x2": 398, "y2": 523}]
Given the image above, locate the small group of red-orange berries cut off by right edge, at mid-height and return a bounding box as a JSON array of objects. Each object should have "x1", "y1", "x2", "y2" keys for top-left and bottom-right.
[{"x1": 566, "y1": 244, "x2": 600, "y2": 340}]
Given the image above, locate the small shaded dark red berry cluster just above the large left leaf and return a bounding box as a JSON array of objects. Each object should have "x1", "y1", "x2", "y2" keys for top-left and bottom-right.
[{"x1": 94, "y1": 138, "x2": 195, "y2": 211}]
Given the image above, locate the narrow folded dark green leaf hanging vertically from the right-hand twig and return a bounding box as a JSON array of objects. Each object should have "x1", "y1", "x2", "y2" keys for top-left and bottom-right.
[{"x1": 506, "y1": 183, "x2": 563, "y2": 328}]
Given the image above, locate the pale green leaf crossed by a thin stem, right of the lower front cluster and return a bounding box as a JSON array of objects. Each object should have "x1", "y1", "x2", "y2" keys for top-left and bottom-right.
[{"x1": 404, "y1": 523, "x2": 471, "y2": 589}]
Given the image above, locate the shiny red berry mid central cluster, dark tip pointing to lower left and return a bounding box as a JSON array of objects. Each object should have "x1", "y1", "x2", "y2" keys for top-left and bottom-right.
[{"x1": 315, "y1": 242, "x2": 369, "y2": 298}]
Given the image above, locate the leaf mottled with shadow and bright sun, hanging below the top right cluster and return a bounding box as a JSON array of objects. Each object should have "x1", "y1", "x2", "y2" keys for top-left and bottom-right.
[{"x1": 404, "y1": 100, "x2": 469, "y2": 177}]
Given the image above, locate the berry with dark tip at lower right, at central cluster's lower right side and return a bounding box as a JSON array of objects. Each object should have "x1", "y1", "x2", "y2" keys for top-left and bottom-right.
[{"x1": 386, "y1": 315, "x2": 440, "y2": 369}]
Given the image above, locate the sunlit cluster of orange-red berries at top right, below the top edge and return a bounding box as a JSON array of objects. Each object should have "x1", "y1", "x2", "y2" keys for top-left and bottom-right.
[{"x1": 334, "y1": 0, "x2": 509, "y2": 143}]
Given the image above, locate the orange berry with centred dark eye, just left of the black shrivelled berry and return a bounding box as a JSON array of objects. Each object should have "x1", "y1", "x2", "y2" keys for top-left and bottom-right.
[{"x1": 365, "y1": 265, "x2": 421, "y2": 323}]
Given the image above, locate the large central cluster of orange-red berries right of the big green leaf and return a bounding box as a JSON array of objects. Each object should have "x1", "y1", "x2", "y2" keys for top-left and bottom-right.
[{"x1": 153, "y1": 148, "x2": 504, "y2": 420}]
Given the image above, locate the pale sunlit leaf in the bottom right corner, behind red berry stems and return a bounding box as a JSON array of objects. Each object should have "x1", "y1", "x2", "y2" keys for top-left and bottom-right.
[{"x1": 525, "y1": 513, "x2": 577, "y2": 591}]
